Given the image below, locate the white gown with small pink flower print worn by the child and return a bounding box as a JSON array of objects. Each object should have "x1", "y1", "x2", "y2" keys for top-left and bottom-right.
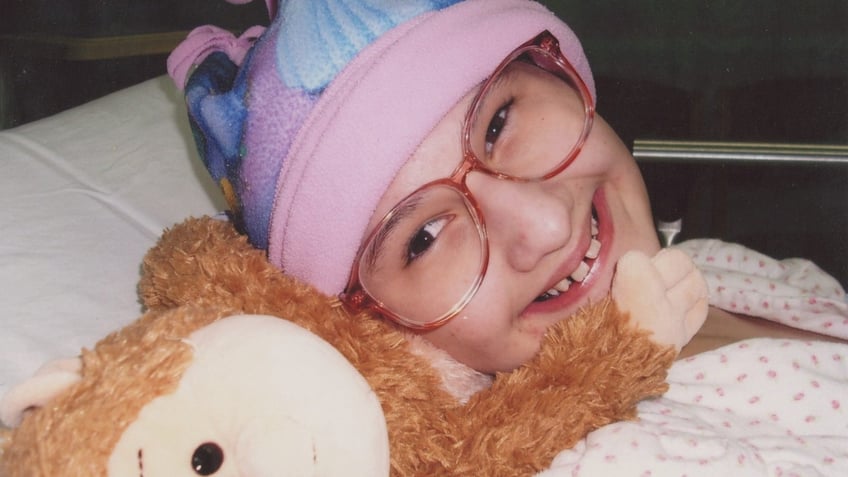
[{"x1": 539, "y1": 240, "x2": 848, "y2": 477}]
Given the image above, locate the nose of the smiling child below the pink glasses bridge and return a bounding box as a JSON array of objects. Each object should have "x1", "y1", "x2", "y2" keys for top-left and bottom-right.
[{"x1": 467, "y1": 172, "x2": 573, "y2": 272}]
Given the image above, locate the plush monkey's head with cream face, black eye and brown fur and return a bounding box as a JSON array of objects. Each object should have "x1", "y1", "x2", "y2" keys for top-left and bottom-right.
[{"x1": 0, "y1": 308, "x2": 389, "y2": 477}]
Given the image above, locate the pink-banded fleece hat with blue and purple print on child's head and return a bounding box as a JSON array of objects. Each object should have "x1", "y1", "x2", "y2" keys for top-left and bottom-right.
[{"x1": 168, "y1": 0, "x2": 595, "y2": 294}]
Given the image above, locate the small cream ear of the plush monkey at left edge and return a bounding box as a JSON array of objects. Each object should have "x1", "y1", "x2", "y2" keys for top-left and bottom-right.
[{"x1": 0, "y1": 357, "x2": 82, "y2": 427}]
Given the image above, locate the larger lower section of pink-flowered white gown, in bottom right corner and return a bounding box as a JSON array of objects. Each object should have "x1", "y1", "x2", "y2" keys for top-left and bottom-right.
[{"x1": 538, "y1": 338, "x2": 848, "y2": 477}]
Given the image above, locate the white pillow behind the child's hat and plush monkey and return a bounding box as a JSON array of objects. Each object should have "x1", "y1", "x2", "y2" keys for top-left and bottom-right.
[{"x1": 0, "y1": 77, "x2": 223, "y2": 395}]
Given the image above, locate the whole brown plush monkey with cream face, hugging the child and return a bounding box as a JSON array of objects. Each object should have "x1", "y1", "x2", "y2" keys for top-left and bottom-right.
[{"x1": 0, "y1": 218, "x2": 706, "y2": 477}]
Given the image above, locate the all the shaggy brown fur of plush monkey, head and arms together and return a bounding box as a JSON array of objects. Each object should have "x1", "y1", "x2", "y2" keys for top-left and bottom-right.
[{"x1": 0, "y1": 219, "x2": 675, "y2": 477}]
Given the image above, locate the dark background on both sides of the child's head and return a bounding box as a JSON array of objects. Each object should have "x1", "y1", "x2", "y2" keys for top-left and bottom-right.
[{"x1": 0, "y1": 0, "x2": 848, "y2": 285}]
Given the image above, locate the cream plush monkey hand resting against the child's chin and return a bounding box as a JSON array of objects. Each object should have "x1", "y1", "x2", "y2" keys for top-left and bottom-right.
[{"x1": 612, "y1": 249, "x2": 709, "y2": 350}]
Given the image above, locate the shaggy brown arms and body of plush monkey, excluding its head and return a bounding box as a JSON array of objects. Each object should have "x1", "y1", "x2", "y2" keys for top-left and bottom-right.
[{"x1": 140, "y1": 219, "x2": 675, "y2": 477}]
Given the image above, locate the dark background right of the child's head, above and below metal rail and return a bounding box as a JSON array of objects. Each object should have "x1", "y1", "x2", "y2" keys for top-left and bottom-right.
[{"x1": 550, "y1": 0, "x2": 848, "y2": 286}]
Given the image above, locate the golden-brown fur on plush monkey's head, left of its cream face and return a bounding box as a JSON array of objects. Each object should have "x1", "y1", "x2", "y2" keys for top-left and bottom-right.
[{"x1": 0, "y1": 306, "x2": 234, "y2": 477}]
